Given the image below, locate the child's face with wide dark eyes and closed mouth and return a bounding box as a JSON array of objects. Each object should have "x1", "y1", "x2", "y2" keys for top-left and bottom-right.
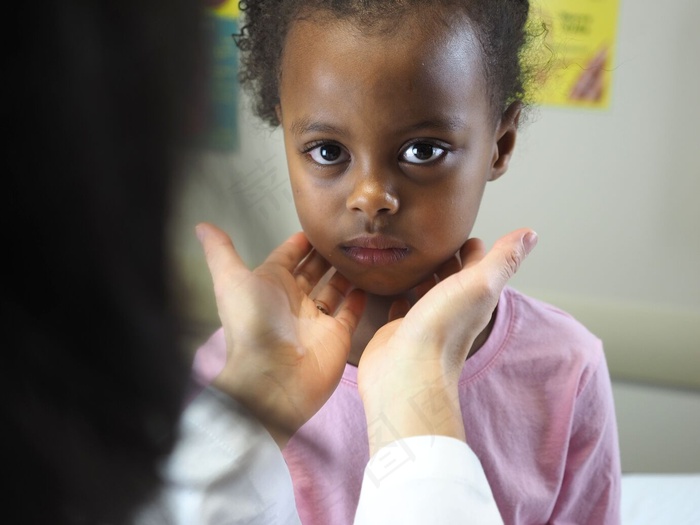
[{"x1": 278, "y1": 13, "x2": 517, "y2": 295}]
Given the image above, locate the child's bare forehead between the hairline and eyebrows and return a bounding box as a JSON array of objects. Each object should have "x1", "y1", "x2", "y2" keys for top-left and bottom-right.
[{"x1": 280, "y1": 11, "x2": 488, "y2": 133}]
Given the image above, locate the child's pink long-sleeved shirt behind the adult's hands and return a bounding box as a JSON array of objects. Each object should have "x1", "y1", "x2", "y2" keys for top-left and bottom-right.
[{"x1": 283, "y1": 288, "x2": 621, "y2": 525}]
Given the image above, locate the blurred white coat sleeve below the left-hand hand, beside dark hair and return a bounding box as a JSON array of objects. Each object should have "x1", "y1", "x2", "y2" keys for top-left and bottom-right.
[{"x1": 136, "y1": 388, "x2": 301, "y2": 525}]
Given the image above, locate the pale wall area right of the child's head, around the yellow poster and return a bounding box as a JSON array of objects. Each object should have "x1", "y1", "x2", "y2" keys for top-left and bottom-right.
[{"x1": 476, "y1": 0, "x2": 700, "y2": 312}]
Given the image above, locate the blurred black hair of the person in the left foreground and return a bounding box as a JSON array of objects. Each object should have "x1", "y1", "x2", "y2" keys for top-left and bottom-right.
[{"x1": 0, "y1": 0, "x2": 205, "y2": 524}]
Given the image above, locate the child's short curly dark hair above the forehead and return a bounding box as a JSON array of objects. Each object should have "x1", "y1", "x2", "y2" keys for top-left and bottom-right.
[{"x1": 233, "y1": 0, "x2": 531, "y2": 127}]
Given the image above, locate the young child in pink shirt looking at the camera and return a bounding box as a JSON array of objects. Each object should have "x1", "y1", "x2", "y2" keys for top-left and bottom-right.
[{"x1": 219, "y1": 0, "x2": 620, "y2": 525}]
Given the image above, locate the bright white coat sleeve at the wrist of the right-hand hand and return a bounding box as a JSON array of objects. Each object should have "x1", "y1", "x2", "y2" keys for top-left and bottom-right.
[{"x1": 355, "y1": 436, "x2": 503, "y2": 525}]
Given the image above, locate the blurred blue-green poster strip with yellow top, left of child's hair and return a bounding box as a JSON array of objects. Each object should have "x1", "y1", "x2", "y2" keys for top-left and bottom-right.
[{"x1": 205, "y1": 0, "x2": 239, "y2": 151}]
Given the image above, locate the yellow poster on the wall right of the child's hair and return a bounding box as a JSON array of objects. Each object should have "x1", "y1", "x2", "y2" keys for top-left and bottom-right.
[{"x1": 531, "y1": 0, "x2": 619, "y2": 109}]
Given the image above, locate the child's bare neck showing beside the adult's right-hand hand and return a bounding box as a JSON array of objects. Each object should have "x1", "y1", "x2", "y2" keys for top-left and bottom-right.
[{"x1": 348, "y1": 288, "x2": 496, "y2": 366}]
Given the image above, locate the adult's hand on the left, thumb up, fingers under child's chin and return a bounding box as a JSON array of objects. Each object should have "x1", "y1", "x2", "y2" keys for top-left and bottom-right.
[{"x1": 196, "y1": 223, "x2": 364, "y2": 448}]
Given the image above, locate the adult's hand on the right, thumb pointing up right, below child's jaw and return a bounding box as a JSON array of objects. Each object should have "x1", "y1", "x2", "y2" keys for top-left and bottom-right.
[{"x1": 358, "y1": 229, "x2": 537, "y2": 453}]
